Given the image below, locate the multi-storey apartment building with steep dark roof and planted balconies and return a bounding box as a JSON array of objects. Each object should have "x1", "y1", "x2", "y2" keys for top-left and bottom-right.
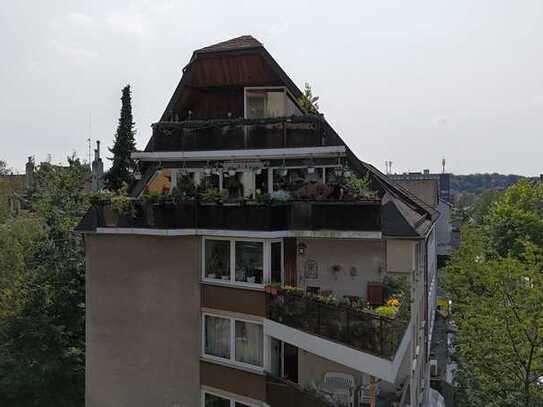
[{"x1": 77, "y1": 36, "x2": 438, "y2": 407}]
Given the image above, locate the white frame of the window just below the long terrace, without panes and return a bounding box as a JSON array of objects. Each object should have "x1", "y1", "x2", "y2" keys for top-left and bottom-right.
[{"x1": 202, "y1": 236, "x2": 285, "y2": 289}]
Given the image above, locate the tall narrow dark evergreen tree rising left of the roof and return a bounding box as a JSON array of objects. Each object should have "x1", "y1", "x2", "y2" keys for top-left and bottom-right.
[{"x1": 104, "y1": 85, "x2": 136, "y2": 191}]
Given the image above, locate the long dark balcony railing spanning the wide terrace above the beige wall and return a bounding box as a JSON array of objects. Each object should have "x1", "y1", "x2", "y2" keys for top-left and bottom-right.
[{"x1": 95, "y1": 200, "x2": 381, "y2": 231}]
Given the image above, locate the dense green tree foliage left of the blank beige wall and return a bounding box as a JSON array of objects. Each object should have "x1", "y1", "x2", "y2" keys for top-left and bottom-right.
[{"x1": 0, "y1": 159, "x2": 89, "y2": 407}]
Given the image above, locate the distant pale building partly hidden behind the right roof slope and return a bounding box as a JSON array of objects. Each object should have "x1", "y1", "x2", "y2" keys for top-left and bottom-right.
[{"x1": 388, "y1": 170, "x2": 453, "y2": 256}]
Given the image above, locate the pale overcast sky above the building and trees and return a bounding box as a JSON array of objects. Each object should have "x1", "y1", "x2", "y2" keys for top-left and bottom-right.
[{"x1": 0, "y1": 0, "x2": 543, "y2": 176}]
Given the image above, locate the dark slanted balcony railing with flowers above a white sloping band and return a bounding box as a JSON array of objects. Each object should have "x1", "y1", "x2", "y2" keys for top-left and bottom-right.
[{"x1": 266, "y1": 291, "x2": 409, "y2": 359}]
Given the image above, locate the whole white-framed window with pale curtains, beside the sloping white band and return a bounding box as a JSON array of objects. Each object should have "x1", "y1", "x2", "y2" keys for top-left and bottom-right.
[{"x1": 203, "y1": 314, "x2": 264, "y2": 368}]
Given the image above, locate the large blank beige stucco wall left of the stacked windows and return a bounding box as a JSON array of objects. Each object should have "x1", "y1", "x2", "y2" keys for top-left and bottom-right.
[{"x1": 85, "y1": 235, "x2": 201, "y2": 407}]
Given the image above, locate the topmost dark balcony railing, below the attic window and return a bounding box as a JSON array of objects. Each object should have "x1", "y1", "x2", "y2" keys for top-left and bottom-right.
[{"x1": 144, "y1": 115, "x2": 340, "y2": 151}]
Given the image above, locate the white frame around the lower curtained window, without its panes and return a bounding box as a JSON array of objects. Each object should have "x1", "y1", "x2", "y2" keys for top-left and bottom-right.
[{"x1": 202, "y1": 312, "x2": 268, "y2": 373}]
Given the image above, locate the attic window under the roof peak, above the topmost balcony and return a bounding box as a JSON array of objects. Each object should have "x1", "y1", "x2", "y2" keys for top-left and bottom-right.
[{"x1": 245, "y1": 87, "x2": 301, "y2": 119}]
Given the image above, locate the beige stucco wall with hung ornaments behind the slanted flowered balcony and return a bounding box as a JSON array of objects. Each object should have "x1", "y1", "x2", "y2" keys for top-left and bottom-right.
[{"x1": 297, "y1": 239, "x2": 385, "y2": 298}]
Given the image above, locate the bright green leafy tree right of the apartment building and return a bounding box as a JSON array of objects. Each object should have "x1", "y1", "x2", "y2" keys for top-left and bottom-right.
[{"x1": 445, "y1": 181, "x2": 543, "y2": 407}]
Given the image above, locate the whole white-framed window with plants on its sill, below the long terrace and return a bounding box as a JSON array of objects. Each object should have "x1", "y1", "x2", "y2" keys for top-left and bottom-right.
[{"x1": 202, "y1": 238, "x2": 283, "y2": 287}]
